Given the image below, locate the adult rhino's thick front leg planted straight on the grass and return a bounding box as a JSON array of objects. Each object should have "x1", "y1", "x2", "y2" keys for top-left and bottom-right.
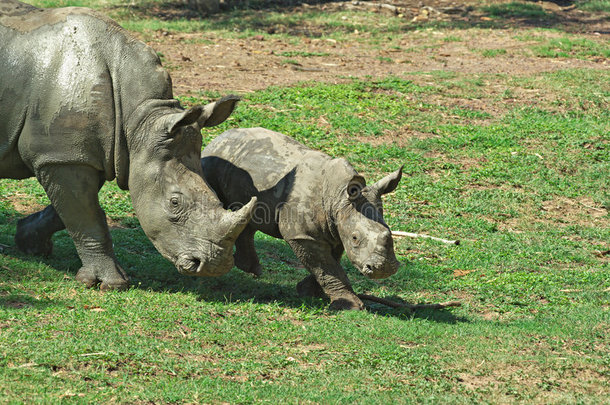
[{"x1": 38, "y1": 166, "x2": 129, "y2": 290}]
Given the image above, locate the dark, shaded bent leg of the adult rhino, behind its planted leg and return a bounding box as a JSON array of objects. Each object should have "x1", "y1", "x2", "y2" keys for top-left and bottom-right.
[{"x1": 15, "y1": 205, "x2": 65, "y2": 256}]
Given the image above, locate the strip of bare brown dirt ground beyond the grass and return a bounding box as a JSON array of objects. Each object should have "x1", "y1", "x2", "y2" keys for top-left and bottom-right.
[{"x1": 148, "y1": 0, "x2": 610, "y2": 95}]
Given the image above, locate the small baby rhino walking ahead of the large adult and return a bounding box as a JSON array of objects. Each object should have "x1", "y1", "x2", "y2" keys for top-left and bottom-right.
[{"x1": 201, "y1": 128, "x2": 402, "y2": 309}]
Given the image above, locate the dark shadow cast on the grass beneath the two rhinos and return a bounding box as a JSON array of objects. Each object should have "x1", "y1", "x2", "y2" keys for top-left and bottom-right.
[{"x1": 0, "y1": 211, "x2": 467, "y2": 323}]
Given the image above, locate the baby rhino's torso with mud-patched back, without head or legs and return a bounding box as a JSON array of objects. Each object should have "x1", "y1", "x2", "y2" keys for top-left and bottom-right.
[{"x1": 202, "y1": 128, "x2": 332, "y2": 239}]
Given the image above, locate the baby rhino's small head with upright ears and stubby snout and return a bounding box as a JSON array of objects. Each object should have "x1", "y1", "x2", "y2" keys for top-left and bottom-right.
[{"x1": 326, "y1": 159, "x2": 402, "y2": 279}]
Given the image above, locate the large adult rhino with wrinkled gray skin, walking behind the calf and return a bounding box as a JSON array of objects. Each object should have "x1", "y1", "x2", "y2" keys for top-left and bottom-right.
[{"x1": 0, "y1": 0, "x2": 254, "y2": 289}]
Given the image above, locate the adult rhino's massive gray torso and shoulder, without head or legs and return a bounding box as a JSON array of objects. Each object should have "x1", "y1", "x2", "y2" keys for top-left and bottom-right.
[{"x1": 0, "y1": 0, "x2": 172, "y2": 180}]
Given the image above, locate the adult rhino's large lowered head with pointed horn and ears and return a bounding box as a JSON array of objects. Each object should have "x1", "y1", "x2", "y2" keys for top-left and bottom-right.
[{"x1": 128, "y1": 97, "x2": 256, "y2": 276}]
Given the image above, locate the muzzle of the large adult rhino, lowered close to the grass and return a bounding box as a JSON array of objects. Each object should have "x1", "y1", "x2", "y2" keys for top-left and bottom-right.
[{"x1": 175, "y1": 242, "x2": 233, "y2": 276}]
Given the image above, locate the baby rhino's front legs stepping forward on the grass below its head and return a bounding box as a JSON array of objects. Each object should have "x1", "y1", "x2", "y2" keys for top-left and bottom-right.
[{"x1": 288, "y1": 239, "x2": 364, "y2": 310}]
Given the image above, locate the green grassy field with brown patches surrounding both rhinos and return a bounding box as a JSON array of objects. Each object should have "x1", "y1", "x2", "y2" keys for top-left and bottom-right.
[{"x1": 0, "y1": 0, "x2": 610, "y2": 404}]
